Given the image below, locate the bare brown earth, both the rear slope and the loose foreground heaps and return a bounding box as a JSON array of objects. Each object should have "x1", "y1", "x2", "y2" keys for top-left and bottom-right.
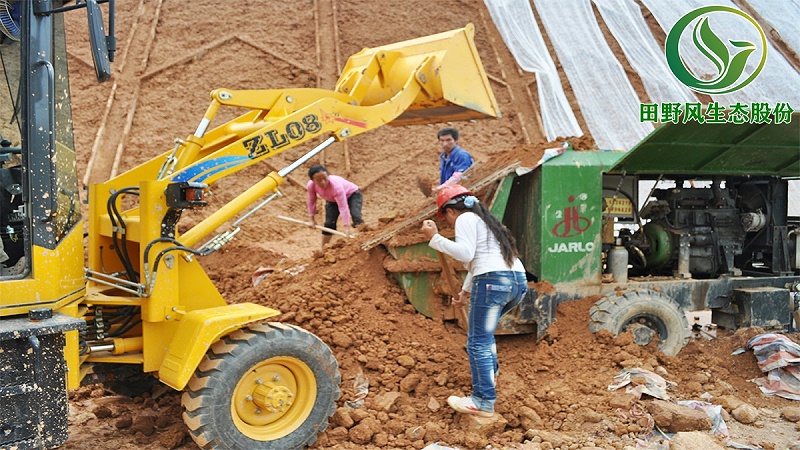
[{"x1": 62, "y1": 0, "x2": 798, "y2": 450}]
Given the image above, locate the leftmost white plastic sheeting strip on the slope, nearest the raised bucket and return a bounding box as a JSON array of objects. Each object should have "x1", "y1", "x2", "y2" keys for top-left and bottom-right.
[{"x1": 483, "y1": 0, "x2": 583, "y2": 141}]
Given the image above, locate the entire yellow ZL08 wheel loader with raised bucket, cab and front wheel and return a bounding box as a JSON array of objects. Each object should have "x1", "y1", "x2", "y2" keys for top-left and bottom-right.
[{"x1": 0, "y1": 0, "x2": 499, "y2": 450}]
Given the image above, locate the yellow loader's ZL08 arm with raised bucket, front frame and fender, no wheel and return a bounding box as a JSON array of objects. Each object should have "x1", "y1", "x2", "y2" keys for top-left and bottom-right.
[{"x1": 86, "y1": 24, "x2": 500, "y2": 389}]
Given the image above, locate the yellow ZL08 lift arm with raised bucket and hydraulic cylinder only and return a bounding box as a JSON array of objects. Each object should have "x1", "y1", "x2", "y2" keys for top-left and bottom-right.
[{"x1": 97, "y1": 24, "x2": 499, "y2": 264}]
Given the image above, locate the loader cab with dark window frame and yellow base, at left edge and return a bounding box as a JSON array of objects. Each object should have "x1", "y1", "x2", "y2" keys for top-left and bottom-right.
[{"x1": 0, "y1": 0, "x2": 96, "y2": 316}]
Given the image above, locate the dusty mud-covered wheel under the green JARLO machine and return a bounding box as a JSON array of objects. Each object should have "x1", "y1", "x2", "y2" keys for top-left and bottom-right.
[{"x1": 589, "y1": 291, "x2": 689, "y2": 356}]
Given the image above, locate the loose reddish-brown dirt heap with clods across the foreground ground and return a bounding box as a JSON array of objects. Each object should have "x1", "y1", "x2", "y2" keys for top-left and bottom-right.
[{"x1": 64, "y1": 235, "x2": 797, "y2": 449}]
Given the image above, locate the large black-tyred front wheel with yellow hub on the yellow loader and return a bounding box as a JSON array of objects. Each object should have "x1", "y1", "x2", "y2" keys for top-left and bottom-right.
[{"x1": 181, "y1": 323, "x2": 341, "y2": 450}]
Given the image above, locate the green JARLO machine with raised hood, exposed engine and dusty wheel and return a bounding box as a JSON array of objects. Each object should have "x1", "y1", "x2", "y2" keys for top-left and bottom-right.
[{"x1": 382, "y1": 114, "x2": 800, "y2": 355}]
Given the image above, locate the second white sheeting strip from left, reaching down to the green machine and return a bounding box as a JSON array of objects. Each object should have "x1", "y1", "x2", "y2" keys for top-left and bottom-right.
[{"x1": 534, "y1": 0, "x2": 653, "y2": 150}]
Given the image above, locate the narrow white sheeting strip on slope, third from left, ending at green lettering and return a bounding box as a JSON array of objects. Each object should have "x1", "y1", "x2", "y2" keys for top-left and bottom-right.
[{"x1": 592, "y1": 0, "x2": 697, "y2": 103}]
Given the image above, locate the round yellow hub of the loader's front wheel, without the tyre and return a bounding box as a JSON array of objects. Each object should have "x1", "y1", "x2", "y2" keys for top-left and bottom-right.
[{"x1": 231, "y1": 356, "x2": 317, "y2": 441}]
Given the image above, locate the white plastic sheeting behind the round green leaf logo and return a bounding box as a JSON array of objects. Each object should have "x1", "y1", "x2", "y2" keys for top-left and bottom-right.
[{"x1": 642, "y1": 0, "x2": 800, "y2": 108}]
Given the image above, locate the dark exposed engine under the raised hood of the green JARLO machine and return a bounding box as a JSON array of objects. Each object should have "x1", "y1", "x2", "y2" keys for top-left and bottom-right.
[{"x1": 617, "y1": 176, "x2": 798, "y2": 279}]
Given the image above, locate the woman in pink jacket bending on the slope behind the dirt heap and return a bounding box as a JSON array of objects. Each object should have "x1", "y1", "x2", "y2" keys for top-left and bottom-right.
[{"x1": 307, "y1": 164, "x2": 364, "y2": 248}]
